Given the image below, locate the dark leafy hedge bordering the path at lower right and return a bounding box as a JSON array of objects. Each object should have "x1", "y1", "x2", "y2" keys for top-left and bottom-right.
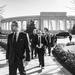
[{"x1": 52, "y1": 44, "x2": 75, "y2": 75}]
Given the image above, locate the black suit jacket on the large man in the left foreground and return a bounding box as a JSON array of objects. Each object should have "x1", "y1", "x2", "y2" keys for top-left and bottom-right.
[{"x1": 6, "y1": 32, "x2": 30, "y2": 64}]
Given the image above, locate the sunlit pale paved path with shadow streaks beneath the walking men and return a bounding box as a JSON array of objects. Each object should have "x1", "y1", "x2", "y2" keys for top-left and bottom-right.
[{"x1": 0, "y1": 47, "x2": 72, "y2": 75}]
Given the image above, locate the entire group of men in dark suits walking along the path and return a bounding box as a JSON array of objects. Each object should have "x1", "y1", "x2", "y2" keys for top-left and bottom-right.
[{"x1": 6, "y1": 21, "x2": 56, "y2": 75}]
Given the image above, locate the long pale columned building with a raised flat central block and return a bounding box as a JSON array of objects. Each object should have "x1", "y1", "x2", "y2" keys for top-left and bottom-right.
[{"x1": 1, "y1": 12, "x2": 75, "y2": 33}]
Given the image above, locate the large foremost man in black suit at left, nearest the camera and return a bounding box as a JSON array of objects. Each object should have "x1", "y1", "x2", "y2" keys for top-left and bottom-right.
[{"x1": 6, "y1": 21, "x2": 30, "y2": 75}]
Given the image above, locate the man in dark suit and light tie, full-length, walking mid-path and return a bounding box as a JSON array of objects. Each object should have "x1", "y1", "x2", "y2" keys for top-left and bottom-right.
[{"x1": 36, "y1": 30, "x2": 47, "y2": 69}]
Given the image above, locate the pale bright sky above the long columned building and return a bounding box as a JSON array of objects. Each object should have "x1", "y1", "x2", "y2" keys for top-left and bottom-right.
[{"x1": 0, "y1": 0, "x2": 75, "y2": 18}]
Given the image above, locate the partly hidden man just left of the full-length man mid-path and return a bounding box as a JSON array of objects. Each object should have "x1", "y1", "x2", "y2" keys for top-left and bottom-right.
[{"x1": 30, "y1": 29, "x2": 37, "y2": 59}]
